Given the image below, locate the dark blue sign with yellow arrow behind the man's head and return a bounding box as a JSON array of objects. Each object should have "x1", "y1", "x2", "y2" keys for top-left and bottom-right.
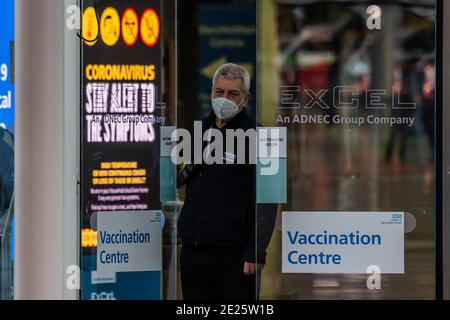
[{"x1": 197, "y1": 5, "x2": 256, "y2": 118}]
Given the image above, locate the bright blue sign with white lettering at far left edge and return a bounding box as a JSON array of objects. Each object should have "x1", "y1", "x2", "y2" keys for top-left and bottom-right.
[{"x1": 0, "y1": 0, "x2": 14, "y2": 133}]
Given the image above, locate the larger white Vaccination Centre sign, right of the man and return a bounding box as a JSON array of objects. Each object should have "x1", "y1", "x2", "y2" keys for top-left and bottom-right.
[{"x1": 282, "y1": 212, "x2": 404, "y2": 274}]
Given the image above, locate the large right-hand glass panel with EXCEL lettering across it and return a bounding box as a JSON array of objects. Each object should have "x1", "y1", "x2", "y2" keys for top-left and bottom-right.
[{"x1": 258, "y1": 0, "x2": 435, "y2": 299}]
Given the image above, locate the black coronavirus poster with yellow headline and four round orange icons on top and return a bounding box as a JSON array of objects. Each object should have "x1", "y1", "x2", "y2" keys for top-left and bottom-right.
[{"x1": 80, "y1": 0, "x2": 162, "y2": 300}]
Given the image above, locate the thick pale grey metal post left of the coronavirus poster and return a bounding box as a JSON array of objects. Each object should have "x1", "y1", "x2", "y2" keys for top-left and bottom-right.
[{"x1": 14, "y1": 0, "x2": 79, "y2": 299}]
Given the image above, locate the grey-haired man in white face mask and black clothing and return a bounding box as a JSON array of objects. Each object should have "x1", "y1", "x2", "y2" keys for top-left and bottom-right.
[{"x1": 179, "y1": 64, "x2": 276, "y2": 300}]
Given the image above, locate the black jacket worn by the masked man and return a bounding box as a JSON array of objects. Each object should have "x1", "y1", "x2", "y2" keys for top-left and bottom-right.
[{"x1": 178, "y1": 109, "x2": 276, "y2": 263}]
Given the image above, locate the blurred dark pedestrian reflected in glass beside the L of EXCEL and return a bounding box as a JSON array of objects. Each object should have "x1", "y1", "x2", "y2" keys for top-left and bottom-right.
[{"x1": 385, "y1": 85, "x2": 415, "y2": 164}]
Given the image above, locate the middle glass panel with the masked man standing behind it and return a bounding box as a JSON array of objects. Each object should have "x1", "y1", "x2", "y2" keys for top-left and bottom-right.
[{"x1": 177, "y1": 0, "x2": 257, "y2": 300}]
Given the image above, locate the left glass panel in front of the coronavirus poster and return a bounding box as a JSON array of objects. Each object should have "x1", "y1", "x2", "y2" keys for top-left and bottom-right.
[{"x1": 80, "y1": 0, "x2": 177, "y2": 300}]
